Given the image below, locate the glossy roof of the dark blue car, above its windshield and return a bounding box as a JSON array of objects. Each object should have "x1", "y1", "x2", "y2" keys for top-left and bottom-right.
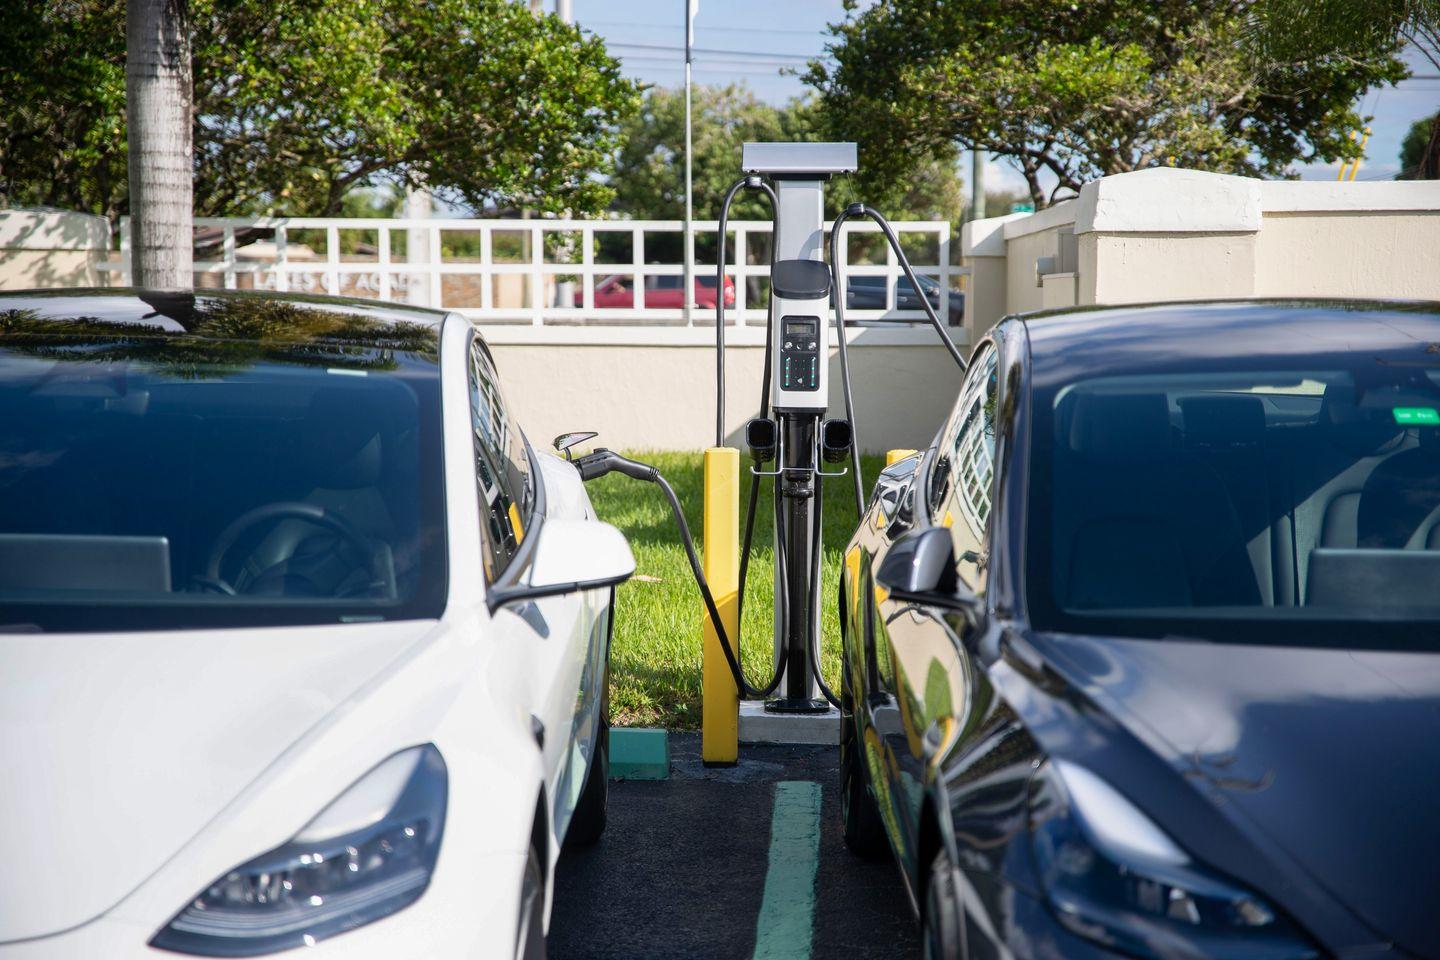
[{"x1": 1012, "y1": 299, "x2": 1440, "y2": 368}]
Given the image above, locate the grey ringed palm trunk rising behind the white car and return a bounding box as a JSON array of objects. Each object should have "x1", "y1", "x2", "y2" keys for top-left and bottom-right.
[{"x1": 125, "y1": 0, "x2": 194, "y2": 289}]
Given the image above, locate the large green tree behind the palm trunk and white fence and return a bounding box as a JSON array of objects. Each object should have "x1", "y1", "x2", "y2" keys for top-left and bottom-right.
[{"x1": 0, "y1": 0, "x2": 639, "y2": 216}]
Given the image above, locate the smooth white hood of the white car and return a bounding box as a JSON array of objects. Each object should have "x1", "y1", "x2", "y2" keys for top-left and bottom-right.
[{"x1": 0, "y1": 622, "x2": 435, "y2": 943}]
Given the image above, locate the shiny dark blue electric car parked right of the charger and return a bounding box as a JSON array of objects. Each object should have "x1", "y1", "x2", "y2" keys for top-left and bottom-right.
[{"x1": 840, "y1": 301, "x2": 1440, "y2": 960}]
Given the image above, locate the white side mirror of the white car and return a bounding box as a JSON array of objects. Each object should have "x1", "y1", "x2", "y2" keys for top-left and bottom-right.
[{"x1": 488, "y1": 520, "x2": 635, "y2": 613}]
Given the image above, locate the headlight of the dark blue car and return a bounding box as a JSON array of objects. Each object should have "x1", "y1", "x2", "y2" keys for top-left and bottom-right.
[{"x1": 1030, "y1": 760, "x2": 1316, "y2": 960}]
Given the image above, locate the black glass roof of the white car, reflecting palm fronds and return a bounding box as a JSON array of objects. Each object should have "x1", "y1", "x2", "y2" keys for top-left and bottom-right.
[{"x1": 0, "y1": 286, "x2": 445, "y2": 343}]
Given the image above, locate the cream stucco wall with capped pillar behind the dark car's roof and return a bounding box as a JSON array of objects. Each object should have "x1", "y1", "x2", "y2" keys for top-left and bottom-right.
[{"x1": 962, "y1": 168, "x2": 1440, "y2": 322}]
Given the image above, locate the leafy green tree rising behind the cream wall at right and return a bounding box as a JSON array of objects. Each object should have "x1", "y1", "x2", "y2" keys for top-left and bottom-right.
[{"x1": 806, "y1": 0, "x2": 1404, "y2": 206}]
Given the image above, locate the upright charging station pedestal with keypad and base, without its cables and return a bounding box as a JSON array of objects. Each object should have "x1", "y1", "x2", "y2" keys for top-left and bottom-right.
[{"x1": 739, "y1": 142, "x2": 857, "y2": 743}]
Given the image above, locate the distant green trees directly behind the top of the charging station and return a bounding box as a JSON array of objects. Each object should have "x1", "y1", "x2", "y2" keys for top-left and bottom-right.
[{"x1": 611, "y1": 85, "x2": 963, "y2": 222}]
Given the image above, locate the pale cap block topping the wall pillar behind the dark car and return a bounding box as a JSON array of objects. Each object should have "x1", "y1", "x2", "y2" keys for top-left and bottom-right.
[{"x1": 1076, "y1": 167, "x2": 1260, "y2": 233}]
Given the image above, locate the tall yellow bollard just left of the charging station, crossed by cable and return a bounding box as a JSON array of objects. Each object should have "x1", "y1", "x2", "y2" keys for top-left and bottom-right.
[{"x1": 700, "y1": 446, "x2": 740, "y2": 764}]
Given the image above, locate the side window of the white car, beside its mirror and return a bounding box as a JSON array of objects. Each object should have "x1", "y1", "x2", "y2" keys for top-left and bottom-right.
[{"x1": 469, "y1": 338, "x2": 534, "y2": 581}]
